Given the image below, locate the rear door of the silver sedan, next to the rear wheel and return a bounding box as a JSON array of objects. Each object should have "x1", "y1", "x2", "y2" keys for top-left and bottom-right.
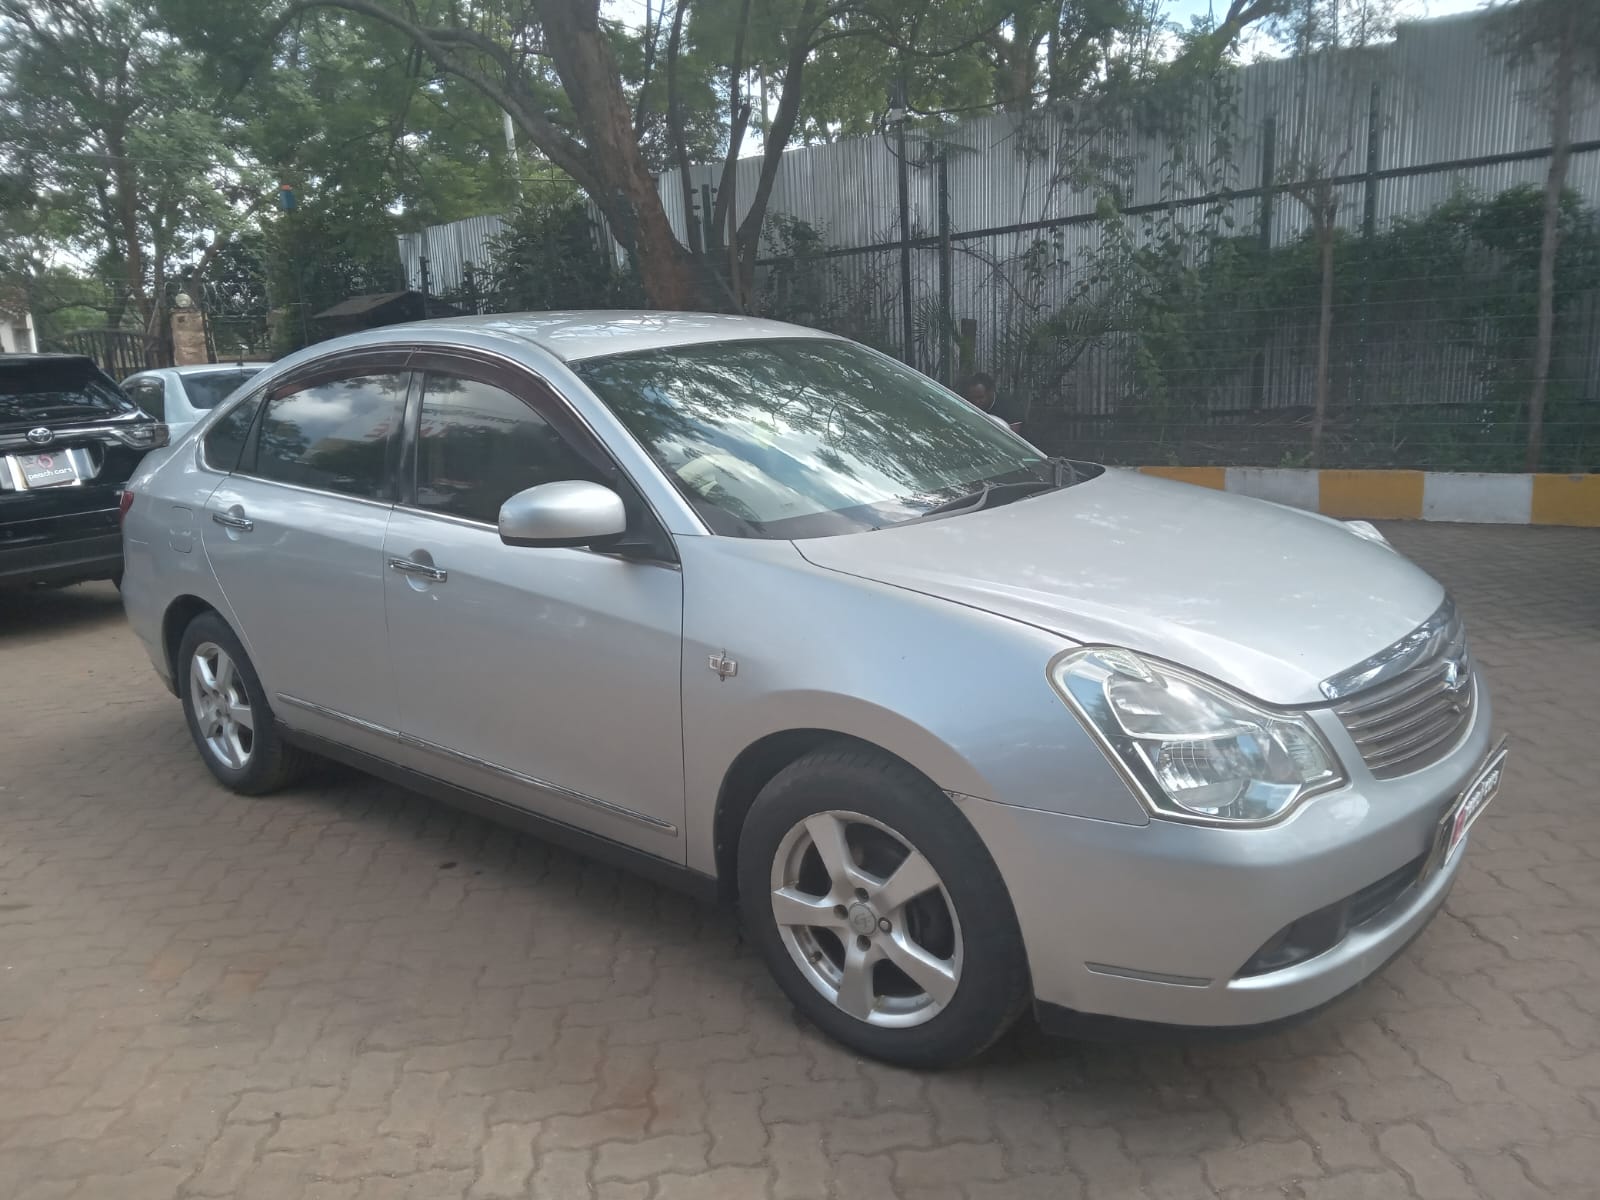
[{"x1": 200, "y1": 354, "x2": 410, "y2": 750}]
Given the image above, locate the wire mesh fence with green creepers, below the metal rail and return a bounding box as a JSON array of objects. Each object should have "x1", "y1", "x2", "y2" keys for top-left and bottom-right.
[{"x1": 745, "y1": 160, "x2": 1600, "y2": 470}]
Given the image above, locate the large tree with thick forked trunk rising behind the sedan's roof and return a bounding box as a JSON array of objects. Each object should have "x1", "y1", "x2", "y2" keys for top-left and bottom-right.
[{"x1": 252, "y1": 0, "x2": 1049, "y2": 315}]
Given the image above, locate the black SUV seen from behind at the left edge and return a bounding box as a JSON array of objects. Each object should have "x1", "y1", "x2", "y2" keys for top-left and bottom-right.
[{"x1": 0, "y1": 354, "x2": 166, "y2": 587}]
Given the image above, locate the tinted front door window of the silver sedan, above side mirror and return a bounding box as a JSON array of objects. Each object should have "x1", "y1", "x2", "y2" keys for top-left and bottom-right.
[{"x1": 416, "y1": 371, "x2": 605, "y2": 523}]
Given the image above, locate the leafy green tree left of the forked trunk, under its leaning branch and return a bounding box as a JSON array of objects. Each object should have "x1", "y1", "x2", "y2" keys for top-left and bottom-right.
[{"x1": 160, "y1": 0, "x2": 528, "y2": 352}]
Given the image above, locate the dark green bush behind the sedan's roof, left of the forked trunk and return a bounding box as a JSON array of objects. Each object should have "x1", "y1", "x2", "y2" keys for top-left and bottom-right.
[{"x1": 488, "y1": 187, "x2": 642, "y2": 312}]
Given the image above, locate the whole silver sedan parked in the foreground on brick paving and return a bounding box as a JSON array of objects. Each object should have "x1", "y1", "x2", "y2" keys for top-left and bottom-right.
[{"x1": 123, "y1": 312, "x2": 1504, "y2": 1066}]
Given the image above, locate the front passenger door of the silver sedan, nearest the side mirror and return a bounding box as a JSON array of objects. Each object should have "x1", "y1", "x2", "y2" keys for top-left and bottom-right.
[{"x1": 384, "y1": 352, "x2": 683, "y2": 862}]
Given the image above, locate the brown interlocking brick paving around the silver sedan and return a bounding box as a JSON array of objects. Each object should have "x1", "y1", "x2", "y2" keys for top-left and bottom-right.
[{"x1": 0, "y1": 526, "x2": 1600, "y2": 1200}]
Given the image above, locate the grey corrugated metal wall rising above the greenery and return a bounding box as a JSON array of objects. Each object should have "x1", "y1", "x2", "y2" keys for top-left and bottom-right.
[{"x1": 400, "y1": 14, "x2": 1600, "y2": 290}]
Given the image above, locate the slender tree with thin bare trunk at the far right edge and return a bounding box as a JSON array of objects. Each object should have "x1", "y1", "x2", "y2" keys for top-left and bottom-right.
[{"x1": 1494, "y1": 0, "x2": 1600, "y2": 470}]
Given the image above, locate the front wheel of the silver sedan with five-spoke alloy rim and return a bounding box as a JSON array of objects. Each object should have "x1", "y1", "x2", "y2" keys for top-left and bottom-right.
[{"x1": 739, "y1": 744, "x2": 1027, "y2": 1067}]
